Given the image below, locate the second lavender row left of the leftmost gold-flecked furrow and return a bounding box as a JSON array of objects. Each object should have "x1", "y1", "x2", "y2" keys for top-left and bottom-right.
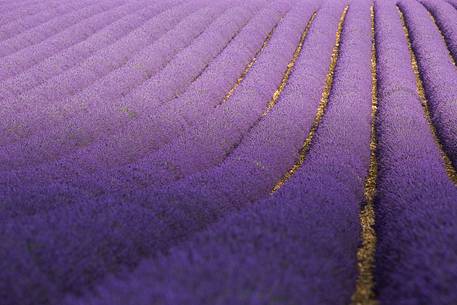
[{"x1": 0, "y1": 2, "x2": 261, "y2": 169}]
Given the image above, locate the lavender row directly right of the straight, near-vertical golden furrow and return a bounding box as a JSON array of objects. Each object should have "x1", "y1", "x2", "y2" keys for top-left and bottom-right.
[{"x1": 375, "y1": 1, "x2": 457, "y2": 305}]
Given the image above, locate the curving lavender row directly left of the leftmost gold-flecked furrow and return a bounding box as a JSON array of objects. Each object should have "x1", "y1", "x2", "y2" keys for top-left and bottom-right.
[{"x1": 0, "y1": 3, "x2": 300, "y2": 197}]
